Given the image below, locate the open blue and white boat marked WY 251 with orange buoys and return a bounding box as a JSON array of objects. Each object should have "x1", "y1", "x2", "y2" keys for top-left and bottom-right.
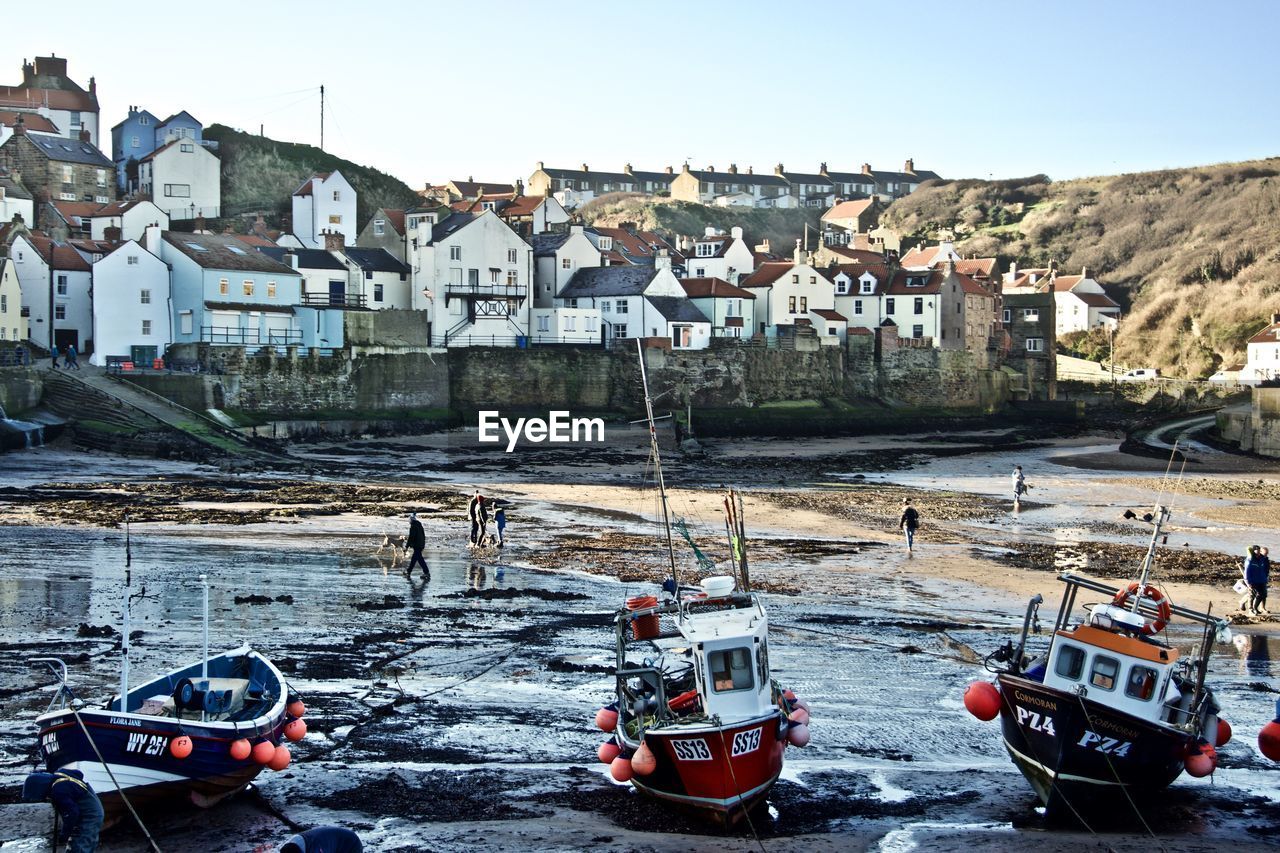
[{"x1": 32, "y1": 560, "x2": 306, "y2": 825}]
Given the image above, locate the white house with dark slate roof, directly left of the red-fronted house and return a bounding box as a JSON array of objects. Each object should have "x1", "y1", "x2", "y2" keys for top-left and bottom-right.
[{"x1": 556, "y1": 256, "x2": 712, "y2": 350}]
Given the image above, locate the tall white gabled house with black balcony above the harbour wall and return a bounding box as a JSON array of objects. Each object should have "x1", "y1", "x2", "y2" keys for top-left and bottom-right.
[{"x1": 407, "y1": 210, "x2": 534, "y2": 347}]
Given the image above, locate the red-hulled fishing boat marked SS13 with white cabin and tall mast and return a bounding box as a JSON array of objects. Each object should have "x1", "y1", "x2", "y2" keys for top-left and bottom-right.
[{"x1": 595, "y1": 340, "x2": 809, "y2": 826}]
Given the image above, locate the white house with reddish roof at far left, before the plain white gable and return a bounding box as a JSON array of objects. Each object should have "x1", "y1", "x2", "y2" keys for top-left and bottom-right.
[{"x1": 9, "y1": 234, "x2": 93, "y2": 356}]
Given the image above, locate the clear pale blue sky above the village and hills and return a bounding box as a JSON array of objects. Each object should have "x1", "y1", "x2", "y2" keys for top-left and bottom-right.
[{"x1": 0, "y1": 0, "x2": 1280, "y2": 187}]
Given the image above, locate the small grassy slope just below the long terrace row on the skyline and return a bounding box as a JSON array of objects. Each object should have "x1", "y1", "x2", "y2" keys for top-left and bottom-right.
[{"x1": 579, "y1": 192, "x2": 822, "y2": 255}]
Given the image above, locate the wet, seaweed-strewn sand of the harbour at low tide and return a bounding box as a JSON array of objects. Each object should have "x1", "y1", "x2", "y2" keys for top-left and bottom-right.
[{"x1": 0, "y1": 430, "x2": 1280, "y2": 853}]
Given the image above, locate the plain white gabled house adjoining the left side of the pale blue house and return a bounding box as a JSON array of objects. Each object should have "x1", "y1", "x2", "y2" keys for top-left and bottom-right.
[{"x1": 90, "y1": 240, "x2": 173, "y2": 366}]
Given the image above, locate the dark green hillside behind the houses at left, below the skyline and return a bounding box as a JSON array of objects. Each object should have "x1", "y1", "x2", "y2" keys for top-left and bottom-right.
[{"x1": 205, "y1": 124, "x2": 419, "y2": 225}]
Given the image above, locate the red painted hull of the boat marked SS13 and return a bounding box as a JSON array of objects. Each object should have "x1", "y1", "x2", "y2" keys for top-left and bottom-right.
[{"x1": 632, "y1": 710, "x2": 786, "y2": 825}]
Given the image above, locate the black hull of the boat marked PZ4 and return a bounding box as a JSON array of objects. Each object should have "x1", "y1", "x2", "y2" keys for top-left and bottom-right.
[{"x1": 996, "y1": 674, "x2": 1196, "y2": 815}]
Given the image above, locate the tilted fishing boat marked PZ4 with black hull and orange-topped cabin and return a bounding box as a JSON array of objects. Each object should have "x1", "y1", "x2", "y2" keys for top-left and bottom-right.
[{"x1": 964, "y1": 505, "x2": 1231, "y2": 817}]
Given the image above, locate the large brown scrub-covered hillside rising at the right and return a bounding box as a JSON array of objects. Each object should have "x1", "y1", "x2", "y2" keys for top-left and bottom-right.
[{"x1": 886, "y1": 158, "x2": 1280, "y2": 377}]
